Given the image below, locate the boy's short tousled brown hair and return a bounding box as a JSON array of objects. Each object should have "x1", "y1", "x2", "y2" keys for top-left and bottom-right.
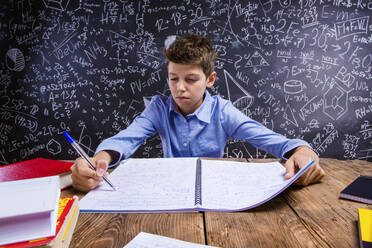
[{"x1": 163, "y1": 34, "x2": 216, "y2": 77}]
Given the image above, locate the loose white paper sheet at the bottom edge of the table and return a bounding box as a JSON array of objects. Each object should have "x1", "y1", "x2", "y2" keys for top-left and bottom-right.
[{"x1": 124, "y1": 232, "x2": 218, "y2": 248}]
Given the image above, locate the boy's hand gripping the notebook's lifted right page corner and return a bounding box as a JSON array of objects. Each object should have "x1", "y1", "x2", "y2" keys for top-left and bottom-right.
[{"x1": 284, "y1": 146, "x2": 325, "y2": 186}]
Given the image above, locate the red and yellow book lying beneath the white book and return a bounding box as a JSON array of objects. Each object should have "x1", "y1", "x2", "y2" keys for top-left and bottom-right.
[{"x1": 0, "y1": 196, "x2": 79, "y2": 248}]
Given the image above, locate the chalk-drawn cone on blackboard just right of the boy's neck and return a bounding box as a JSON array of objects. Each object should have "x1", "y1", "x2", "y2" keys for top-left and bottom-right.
[{"x1": 223, "y1": 70, "x2": 254, "y2": 110}]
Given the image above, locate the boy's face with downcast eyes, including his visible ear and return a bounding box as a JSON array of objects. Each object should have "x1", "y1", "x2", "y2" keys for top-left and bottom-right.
[{"x1": 168, "y1": 62, "x2": 216, "y2": 116}]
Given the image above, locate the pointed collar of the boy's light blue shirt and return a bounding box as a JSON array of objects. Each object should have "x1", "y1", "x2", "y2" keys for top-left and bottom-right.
[{"x1": 167, "y1": 90, "x2": 213, "y2": 123}]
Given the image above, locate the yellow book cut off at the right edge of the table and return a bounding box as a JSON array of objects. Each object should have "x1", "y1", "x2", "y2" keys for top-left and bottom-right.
[{"x1": 358, "y1": 208, "x2": 372, "y2": 248}]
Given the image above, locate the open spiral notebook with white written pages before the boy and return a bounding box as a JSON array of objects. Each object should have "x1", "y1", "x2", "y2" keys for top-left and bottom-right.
[{"x1": 80, "y1": 158, "x2": 314, "y2": 212}]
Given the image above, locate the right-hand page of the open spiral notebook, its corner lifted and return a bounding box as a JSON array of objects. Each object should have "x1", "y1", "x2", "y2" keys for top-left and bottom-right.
[{"x1": 201, "y1": 160, "x2": 308, "y2": 211}]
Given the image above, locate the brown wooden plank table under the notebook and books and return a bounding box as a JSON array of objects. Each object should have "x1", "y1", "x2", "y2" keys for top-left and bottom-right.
[{"x1": 62, "y1": 159, "x2": 372, "y2": 248}]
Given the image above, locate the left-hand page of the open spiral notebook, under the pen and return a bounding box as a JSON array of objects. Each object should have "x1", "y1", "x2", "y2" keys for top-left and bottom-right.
[{"x1": 79, "y1": 158, "x2": 196, "y2": 212}]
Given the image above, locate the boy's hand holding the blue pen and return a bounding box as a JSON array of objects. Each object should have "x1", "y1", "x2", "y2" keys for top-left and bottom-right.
[{"x1": 71, "y1": 151, "x2": 111, "y2": 192}]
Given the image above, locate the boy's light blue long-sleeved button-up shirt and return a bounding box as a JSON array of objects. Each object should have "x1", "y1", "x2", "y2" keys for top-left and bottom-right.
[{"x1": 96, "y1": 90, "x2": 311, "y2": 164}]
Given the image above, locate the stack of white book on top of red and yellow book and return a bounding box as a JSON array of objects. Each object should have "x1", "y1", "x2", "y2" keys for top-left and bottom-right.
[{"x1": 0, "y1": 163, "x2": 79, "y2": 248}]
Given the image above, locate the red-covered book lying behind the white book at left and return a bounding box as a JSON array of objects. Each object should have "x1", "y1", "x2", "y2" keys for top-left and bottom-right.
[{"x1": 0, "y1": 158, "x2": 73, "y2": 189}]
